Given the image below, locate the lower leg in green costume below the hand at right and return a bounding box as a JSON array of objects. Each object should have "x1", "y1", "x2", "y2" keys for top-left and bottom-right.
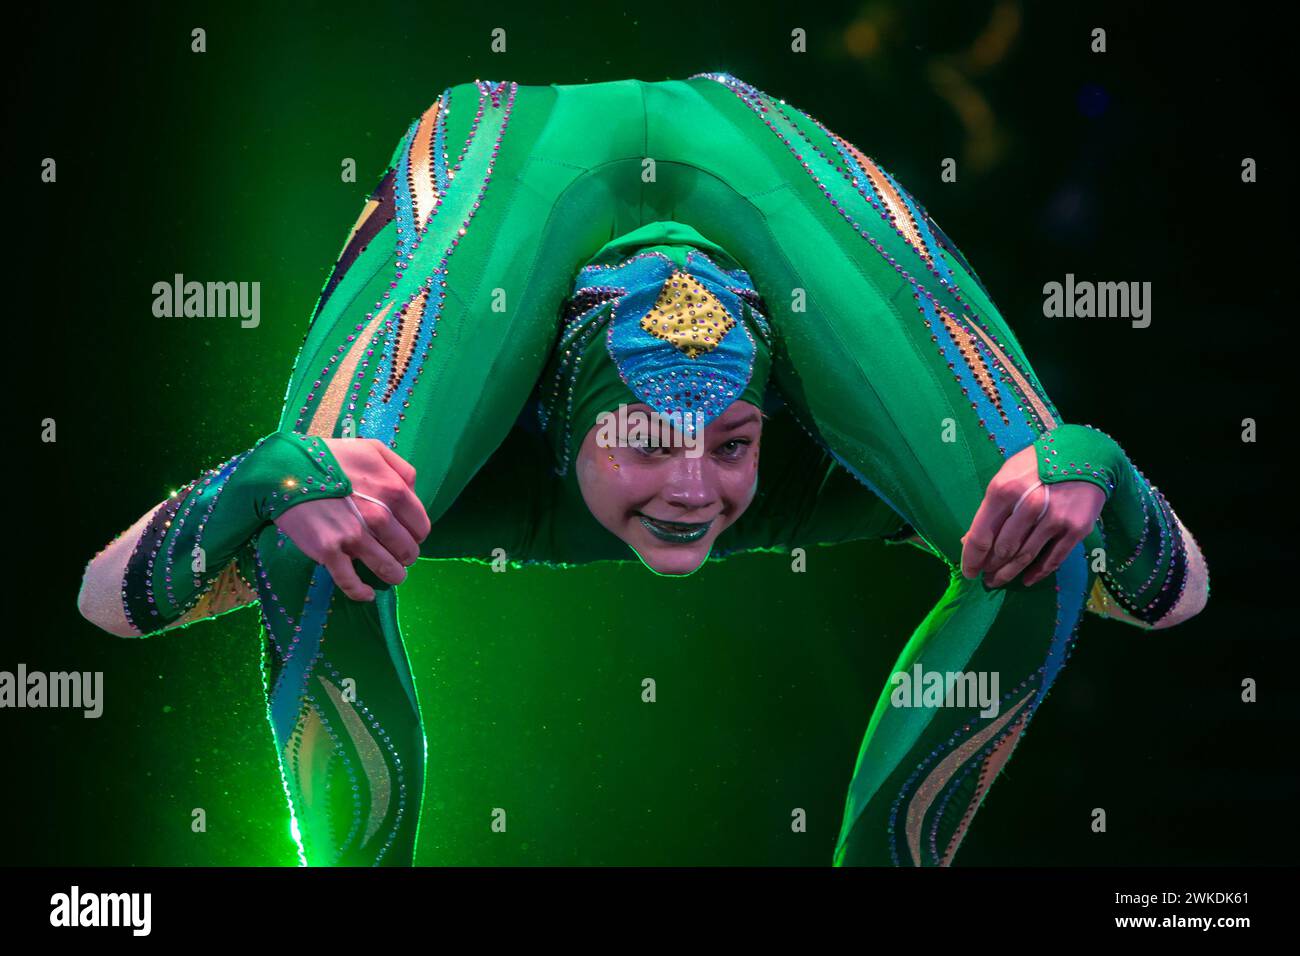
[{"x1": 835, "y1": 548, "x2": 1091, "y2": 866}]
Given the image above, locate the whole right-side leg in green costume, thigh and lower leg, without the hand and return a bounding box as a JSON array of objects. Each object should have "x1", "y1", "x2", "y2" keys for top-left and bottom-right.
[{"x1": 651, "y1": 74, "x2": 1091, "y2": 865}]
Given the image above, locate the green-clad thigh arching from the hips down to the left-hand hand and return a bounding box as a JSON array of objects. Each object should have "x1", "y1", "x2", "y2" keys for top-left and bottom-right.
[{"x1": 282, "y1": 81, "x2": 655, "y2": 520}]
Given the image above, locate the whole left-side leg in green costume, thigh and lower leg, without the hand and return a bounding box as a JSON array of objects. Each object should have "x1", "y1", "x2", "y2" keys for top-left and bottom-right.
[{"x1": 256, "y1": 81, "x2": 655, "y2": 864}]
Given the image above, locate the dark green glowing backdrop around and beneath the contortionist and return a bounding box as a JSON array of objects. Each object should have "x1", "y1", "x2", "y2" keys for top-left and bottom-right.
[{"x1": 0, "y1": 0, "x2": 1297, "y2": 865}]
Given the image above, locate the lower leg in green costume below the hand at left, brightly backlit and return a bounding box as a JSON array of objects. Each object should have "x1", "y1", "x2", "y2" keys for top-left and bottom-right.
[{"x1": 250, "y1": 525, "x2": 425, "y2": 866}]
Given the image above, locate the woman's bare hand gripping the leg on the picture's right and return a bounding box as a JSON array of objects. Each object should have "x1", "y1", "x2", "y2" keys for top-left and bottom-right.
[{"x1": 962, "y1": 445, "x2": 1106, "y2": 588}]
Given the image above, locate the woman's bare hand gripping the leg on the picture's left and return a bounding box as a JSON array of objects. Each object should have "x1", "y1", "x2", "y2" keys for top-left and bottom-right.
[{"x1": 276, "y1": 438, "x2": 430, "y2": 601}]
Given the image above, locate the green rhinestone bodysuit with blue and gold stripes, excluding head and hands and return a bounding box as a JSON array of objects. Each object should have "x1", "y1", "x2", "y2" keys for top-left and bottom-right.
[{"x1": 91, "y1": 73, "x2": 1208, "y2": 866}]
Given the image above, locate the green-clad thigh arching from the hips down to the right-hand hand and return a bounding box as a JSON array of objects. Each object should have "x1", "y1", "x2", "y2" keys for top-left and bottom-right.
[{"x1": 647, "y1": 74, "x2": 1056, "y2": 564}]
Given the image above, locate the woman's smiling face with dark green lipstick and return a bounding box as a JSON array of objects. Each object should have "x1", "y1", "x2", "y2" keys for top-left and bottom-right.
[{"x1": 577, "y1": 401, "x2": 763, "y2": 575}]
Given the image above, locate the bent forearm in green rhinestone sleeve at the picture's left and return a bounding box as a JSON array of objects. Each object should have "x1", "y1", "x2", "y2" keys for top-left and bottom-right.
[{"x1": 78, "y1": 432, "x2": 351, "y2": 637}]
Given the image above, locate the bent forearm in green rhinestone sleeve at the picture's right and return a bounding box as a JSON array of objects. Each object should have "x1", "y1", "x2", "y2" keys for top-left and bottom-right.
[{"x1": 1035, "y1": 425, "x2": 1209, "y2": 628}]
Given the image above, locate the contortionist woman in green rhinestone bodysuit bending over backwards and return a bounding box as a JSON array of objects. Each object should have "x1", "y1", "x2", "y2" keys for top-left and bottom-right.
[{"x1": 79, "y1": 73, "x2": 1209, "y2": 866}]
